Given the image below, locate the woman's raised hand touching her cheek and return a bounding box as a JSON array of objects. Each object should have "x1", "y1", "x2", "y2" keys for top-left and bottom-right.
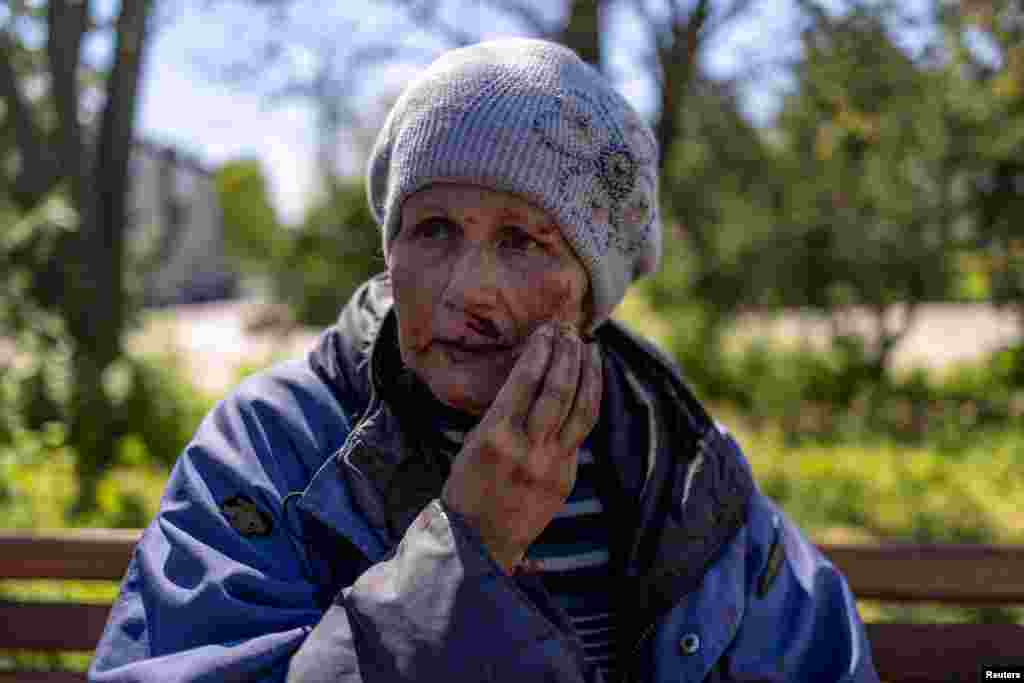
[{"x1": 441, "y1": 323, "x2": 603, "y2": 572}]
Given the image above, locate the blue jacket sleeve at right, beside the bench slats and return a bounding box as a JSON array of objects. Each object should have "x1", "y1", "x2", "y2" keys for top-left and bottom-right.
[{"x1": 725, "y1": 492, "x2": 879, "y2": 683}]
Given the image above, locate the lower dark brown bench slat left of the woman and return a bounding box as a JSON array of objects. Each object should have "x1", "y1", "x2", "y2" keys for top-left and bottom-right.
[{"x1": 0, "y1": 602, "x2": 111, "y2": 650}]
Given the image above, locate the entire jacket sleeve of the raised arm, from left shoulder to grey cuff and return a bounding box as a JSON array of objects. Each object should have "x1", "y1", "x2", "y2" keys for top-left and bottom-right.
[{"x1": 89, "y1": 368, "x2": 600, "y2": 683}]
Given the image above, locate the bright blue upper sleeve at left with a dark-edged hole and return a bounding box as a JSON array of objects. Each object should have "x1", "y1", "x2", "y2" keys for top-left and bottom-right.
[{"x1": 89, "y1": 373, "x2": 339, "y2": 683}]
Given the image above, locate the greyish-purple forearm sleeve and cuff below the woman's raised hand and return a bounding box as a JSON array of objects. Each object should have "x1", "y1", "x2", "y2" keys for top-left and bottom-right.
[{"x1": 288, "y1": 499, "x2": 603, "y2": 683}]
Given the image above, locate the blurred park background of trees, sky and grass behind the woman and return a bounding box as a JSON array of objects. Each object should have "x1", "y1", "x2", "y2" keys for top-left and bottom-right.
[{"x1": 0, "y1": 0, "x2": 1024, "y2": 671}]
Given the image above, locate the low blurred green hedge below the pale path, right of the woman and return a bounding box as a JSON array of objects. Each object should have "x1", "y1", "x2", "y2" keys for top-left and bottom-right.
[{"x1": 671, "y1": 321, "x2": 1024, "y2": 451}]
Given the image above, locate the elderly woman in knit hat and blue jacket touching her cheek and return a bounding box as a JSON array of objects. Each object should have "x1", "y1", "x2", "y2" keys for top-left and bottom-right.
[{"x1": 90, "y1": 39, "x2": 877, "y2": 683}]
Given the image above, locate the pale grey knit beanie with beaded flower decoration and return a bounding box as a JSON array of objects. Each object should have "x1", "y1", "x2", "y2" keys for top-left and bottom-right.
[{"x1": 367, "y1": 38, "x2": 662, "y2": 334}]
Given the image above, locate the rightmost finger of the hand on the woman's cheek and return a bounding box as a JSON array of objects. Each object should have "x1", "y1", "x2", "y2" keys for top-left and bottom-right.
[{"x1": 526, "y1": 329, "x2": 583, "y2": 443}]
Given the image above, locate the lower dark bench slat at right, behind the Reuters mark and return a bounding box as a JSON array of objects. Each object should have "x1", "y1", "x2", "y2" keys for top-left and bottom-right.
[{"x1": 865, "y1": 624, "x2": 1024, "y2": 683}]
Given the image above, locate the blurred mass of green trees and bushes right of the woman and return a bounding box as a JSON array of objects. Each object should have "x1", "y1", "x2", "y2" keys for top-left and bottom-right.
[{"x1": 640, "y1": 3, "x2": 1024, "y2": 442}]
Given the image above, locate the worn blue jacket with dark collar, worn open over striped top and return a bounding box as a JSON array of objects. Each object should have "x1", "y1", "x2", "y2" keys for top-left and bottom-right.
[{"x1": 89, "y1": 276, "x2": 878, "y2": 683}]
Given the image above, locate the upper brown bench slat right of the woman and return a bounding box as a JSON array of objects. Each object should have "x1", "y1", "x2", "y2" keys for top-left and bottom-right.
[{"x1": 820, "y1": 544, "x2": 1024, "y2": 605}]
